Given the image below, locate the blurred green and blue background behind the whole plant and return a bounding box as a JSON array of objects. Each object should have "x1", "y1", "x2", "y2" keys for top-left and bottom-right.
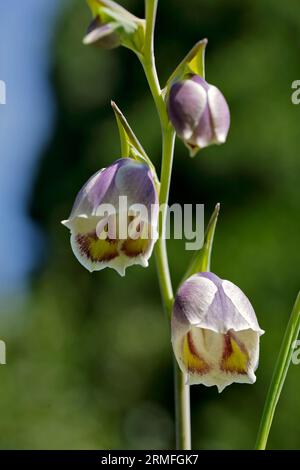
[{"x1": 0, "y1": 0, "x2": 300, "y2": 449}]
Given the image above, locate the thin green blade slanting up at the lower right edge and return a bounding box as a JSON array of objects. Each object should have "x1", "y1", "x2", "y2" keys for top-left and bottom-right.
[{"x1": 255, "y1": 293, "x2": 300, "y2": 450}]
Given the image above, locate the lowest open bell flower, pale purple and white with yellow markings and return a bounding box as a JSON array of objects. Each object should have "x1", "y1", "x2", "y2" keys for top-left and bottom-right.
[{"x1": 172, "y1": 272, "x2": 264, "y2": 392}]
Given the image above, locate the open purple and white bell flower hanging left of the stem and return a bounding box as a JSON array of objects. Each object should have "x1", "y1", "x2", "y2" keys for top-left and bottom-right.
[{"x1": 62, "y1": 158, "x2": 158, "y2": 276}]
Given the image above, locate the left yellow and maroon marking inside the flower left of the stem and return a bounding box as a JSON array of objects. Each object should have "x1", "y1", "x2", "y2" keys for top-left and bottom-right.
[{"x1": 76, "y1": 233, "x2": 119, "y2": 262}]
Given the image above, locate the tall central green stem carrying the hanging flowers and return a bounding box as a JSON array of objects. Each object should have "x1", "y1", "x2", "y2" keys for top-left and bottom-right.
[{"x1": 140, "y1": 0, "x2": 191, "y2": 450}]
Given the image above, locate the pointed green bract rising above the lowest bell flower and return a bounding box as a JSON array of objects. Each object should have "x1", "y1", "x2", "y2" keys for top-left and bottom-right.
[{"x1": 183, "y1": 203, "x2": 220, "y2": 281}]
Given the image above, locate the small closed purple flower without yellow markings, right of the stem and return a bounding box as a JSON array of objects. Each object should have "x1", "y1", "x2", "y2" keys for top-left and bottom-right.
[{"x1": 167, "y1": 75, "x2": 230, "y2": 156}]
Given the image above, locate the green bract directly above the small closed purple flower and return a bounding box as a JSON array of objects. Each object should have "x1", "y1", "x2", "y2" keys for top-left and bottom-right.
[{"x1": 166, "y1": 39, "x2": 208, "y2": 89}]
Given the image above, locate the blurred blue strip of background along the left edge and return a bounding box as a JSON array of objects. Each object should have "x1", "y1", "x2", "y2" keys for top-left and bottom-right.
[{"x1": 0, "y1": 0, "x2": 58, "y2": 294}]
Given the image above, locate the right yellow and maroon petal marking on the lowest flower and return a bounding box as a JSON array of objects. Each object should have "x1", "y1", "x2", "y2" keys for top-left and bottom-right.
[{"x1": 221, "y1": 333, "x2": 249, "y2": 374}]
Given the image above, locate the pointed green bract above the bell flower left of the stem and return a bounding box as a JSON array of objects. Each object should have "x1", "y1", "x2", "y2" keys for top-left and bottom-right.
[{"x1": 111, "y1": 101, "x2": 159, "y2": 187}]
